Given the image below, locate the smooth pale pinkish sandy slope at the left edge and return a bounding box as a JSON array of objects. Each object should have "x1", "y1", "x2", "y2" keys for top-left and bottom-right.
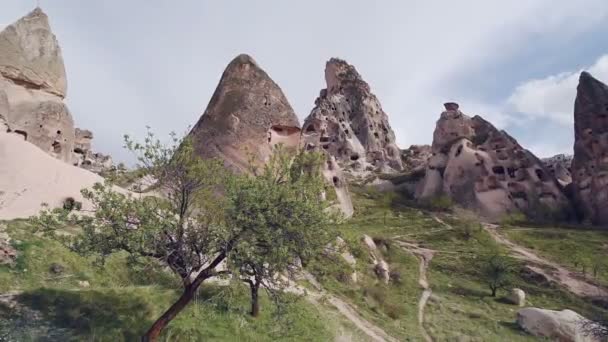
[{"x1": 0, "y1": 133, "x2": 103, "y2": 220}]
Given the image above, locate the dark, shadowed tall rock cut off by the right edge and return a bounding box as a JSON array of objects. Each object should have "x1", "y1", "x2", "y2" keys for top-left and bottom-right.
[{"x1": 572, "y1": 72, "x2": 608, "y2": 225}]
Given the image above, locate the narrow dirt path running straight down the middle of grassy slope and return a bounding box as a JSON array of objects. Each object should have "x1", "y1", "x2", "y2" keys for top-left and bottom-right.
[{"x1": 396, "y1": 241, "x2": 435, "y2": 342}]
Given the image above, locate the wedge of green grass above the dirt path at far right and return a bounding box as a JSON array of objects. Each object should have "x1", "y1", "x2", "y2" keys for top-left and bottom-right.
[{"x1": 503, "y1": 227, "x2": 608, "y2": 286}]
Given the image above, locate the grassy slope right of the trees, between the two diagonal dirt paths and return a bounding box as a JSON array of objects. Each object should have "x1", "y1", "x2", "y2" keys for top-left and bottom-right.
[{"x1": 312, "y1": 189, "x2": 607, "y2": 341}]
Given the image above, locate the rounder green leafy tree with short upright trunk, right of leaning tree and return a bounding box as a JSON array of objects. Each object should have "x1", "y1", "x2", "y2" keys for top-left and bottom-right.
[{"x1": 227, "y1": 145, "x2": 333, "y2": 317}]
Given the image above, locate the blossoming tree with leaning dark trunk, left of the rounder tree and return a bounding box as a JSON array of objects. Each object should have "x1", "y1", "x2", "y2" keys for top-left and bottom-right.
[{"x1": 34, "y1": 132, "x2": 234, "y2": 341}]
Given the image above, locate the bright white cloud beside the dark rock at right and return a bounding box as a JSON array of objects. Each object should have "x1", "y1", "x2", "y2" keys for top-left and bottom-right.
[{"x1": 507, "y1": 54, "x2": 608, "y2": 125}]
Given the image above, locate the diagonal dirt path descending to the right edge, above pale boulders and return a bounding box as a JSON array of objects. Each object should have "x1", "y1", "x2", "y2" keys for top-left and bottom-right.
[{"x1": 483, "y1": 223, "x2": 608, "y2": 297}]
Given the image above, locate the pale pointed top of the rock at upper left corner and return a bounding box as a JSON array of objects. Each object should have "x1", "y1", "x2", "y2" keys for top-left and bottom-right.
[{"x1": 0, "y1": 7, "x2": 67, "y2": 97}]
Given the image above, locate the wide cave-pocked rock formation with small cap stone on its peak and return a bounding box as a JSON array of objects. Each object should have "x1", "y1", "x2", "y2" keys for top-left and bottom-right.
[{"x1": 416, "y1": 103, "x2": 569, "y2": 219}]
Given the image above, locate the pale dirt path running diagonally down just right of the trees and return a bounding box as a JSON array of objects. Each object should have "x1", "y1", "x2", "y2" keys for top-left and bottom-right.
[{"x1": 291, "y1": 272, "x2": 398, "y2": 342}]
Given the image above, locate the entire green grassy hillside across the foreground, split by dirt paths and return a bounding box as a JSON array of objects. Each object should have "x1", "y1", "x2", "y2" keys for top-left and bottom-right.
[{"x1": 0, "y1": 189, "x2": 608, "y2": 341}]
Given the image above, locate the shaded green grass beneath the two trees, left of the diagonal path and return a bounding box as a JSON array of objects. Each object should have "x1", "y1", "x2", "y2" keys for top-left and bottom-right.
[{"x1": 0, "y1": 222, "x2": 338, "y2": 341}]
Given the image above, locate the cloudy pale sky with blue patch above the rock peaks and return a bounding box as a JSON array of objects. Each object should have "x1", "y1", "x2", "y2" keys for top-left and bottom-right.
[{"x1": 0, "y1": 0, "x2": 608, "y2": 162}]
